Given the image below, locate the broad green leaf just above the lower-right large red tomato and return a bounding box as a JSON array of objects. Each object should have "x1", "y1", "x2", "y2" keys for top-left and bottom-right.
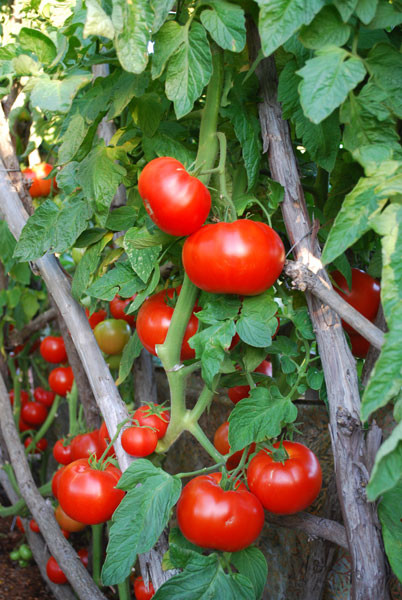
[{"x1": 229, "y1": 386, "x2": 297, "y2": 452}]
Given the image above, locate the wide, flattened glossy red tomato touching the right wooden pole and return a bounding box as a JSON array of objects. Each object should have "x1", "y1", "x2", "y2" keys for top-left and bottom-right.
[{"x1": 183, "y1": 219, "x2": 285, "y2": 296}]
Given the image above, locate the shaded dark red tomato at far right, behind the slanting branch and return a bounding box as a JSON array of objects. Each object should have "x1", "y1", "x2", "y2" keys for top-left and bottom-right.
[{"x1": 331, "y1": 269, "x2": 381, "y2": 335}]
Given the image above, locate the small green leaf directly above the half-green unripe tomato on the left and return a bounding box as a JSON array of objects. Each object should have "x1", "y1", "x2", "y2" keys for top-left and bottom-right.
[{"x1": 87, "y1": 262, "x2": 144, "y2": 302}]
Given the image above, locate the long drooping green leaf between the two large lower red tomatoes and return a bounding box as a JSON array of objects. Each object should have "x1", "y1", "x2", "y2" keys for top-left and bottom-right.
[{"x1": 102, "y1": 459, "x2": 181, "y2": 585}]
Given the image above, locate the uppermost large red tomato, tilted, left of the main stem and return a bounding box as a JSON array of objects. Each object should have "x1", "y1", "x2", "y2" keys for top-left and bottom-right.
[{"x1": 138, "y1": 156, "x2": 211, "y2": 235}]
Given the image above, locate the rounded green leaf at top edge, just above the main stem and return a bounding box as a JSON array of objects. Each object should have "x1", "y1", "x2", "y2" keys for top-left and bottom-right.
[{"x1": 200, "y1": 0, "x2": 246, "y2": 52}]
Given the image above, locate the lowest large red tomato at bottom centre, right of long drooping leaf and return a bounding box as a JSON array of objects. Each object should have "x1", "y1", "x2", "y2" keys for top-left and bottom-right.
[{"x1": 177, "y1": 473, "x2": 264, "y2": 552}]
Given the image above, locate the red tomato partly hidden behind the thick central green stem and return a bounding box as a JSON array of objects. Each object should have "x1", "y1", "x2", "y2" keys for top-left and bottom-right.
[{"x1": 137, "y1": 288, "x2": 199, "y2": 360}]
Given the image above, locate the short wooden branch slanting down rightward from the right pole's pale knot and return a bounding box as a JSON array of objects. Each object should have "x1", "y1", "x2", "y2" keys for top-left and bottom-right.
[{"x1": 283, "y1": 260, "x2": 384, "y2": 349}]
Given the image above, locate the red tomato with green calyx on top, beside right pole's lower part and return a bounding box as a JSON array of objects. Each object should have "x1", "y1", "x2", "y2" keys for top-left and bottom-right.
[{"x1": 247, "y1": 442, "x2": 322, "y2": 515}]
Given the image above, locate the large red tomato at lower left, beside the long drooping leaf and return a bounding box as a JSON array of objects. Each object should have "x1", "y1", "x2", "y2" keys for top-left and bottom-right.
[{"x1": 58, "y1": 458, "x2": 124, "y2": 525}]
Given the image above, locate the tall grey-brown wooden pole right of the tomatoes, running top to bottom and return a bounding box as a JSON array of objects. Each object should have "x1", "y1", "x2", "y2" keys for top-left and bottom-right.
[{"x1": 248, "y1": 23, "x2": 389, "y2": 600}]
